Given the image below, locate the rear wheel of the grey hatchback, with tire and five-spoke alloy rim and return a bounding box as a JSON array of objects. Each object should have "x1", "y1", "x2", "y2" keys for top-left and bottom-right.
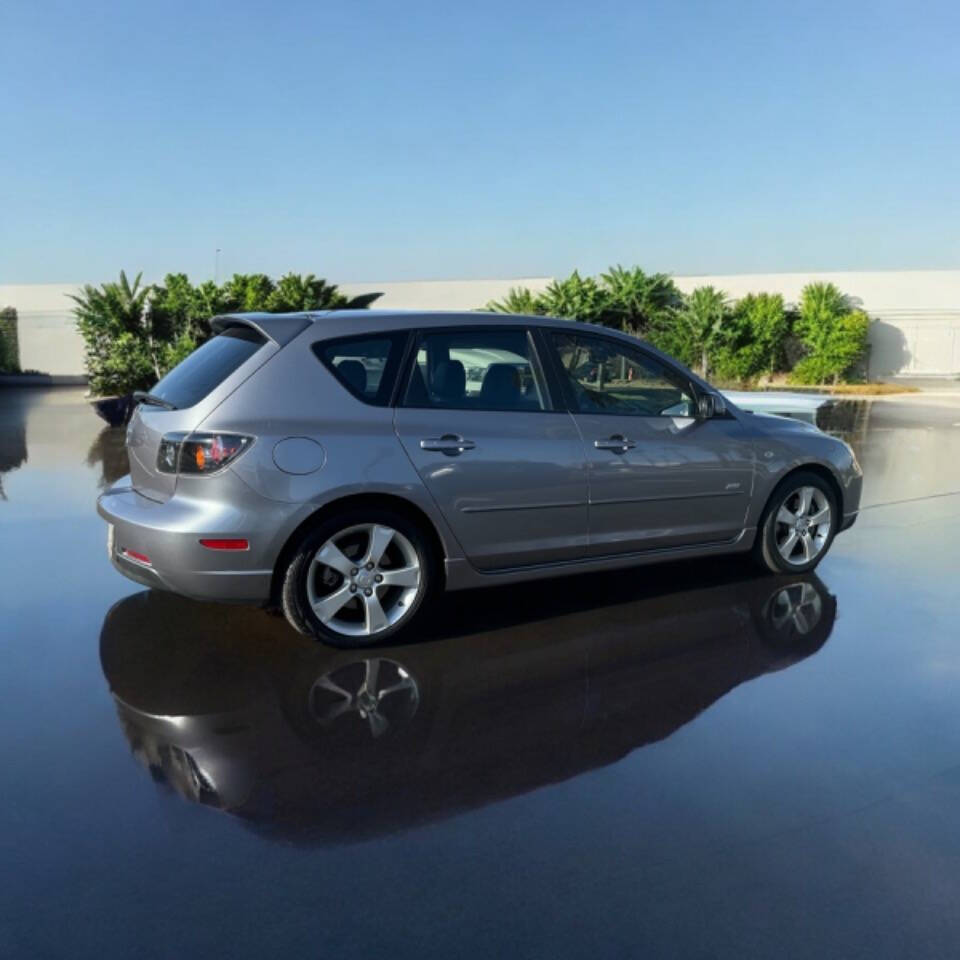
[{"x1": 281, "y1": 506, "x2": 438, "y2": 649}]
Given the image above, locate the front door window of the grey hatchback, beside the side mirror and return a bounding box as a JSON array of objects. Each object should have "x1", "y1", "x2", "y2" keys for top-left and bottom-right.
[{"x1": 552, "y1": 333, "x2": 696, "y2": 417}]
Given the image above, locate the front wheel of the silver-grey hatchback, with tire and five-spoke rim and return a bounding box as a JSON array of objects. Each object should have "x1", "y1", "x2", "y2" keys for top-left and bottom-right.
[{"x1": 753, "y1": 470, "x2": 840, "y2": 573}]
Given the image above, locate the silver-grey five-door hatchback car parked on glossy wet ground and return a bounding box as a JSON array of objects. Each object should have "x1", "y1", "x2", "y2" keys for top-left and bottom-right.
[{"x1": 98, "y1": 310, "x2": 862, "y2": 647}]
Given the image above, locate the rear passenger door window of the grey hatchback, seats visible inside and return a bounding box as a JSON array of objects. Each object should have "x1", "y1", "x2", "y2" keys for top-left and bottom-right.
[{"x1": 404, "y1": 329, "x2": 549, "y2": 410}]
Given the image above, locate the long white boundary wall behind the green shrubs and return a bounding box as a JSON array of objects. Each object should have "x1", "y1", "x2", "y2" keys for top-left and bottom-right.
[{"x1": 0, "y1": 270, "x2": 960, "y2": 376}]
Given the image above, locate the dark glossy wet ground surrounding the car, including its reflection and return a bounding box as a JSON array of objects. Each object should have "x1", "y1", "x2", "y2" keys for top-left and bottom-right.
[{"x1": 0, "y1": 390, "x2": 960, "y2": 958}]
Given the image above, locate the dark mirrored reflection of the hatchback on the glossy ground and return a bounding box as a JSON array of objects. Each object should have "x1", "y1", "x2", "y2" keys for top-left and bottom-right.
[{"x1": 100, "y1": 574, "x2": 836, "y2": 840}]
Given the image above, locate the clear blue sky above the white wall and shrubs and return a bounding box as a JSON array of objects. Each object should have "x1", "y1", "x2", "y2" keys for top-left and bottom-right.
[{"x1": 0, "y1": 0, "x2": 960, "y2": 283}]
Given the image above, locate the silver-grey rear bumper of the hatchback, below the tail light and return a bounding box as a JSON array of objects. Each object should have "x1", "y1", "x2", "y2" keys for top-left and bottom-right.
[{"x1": 97, "y1": 481, "x2": 303, "y2": 603}]
